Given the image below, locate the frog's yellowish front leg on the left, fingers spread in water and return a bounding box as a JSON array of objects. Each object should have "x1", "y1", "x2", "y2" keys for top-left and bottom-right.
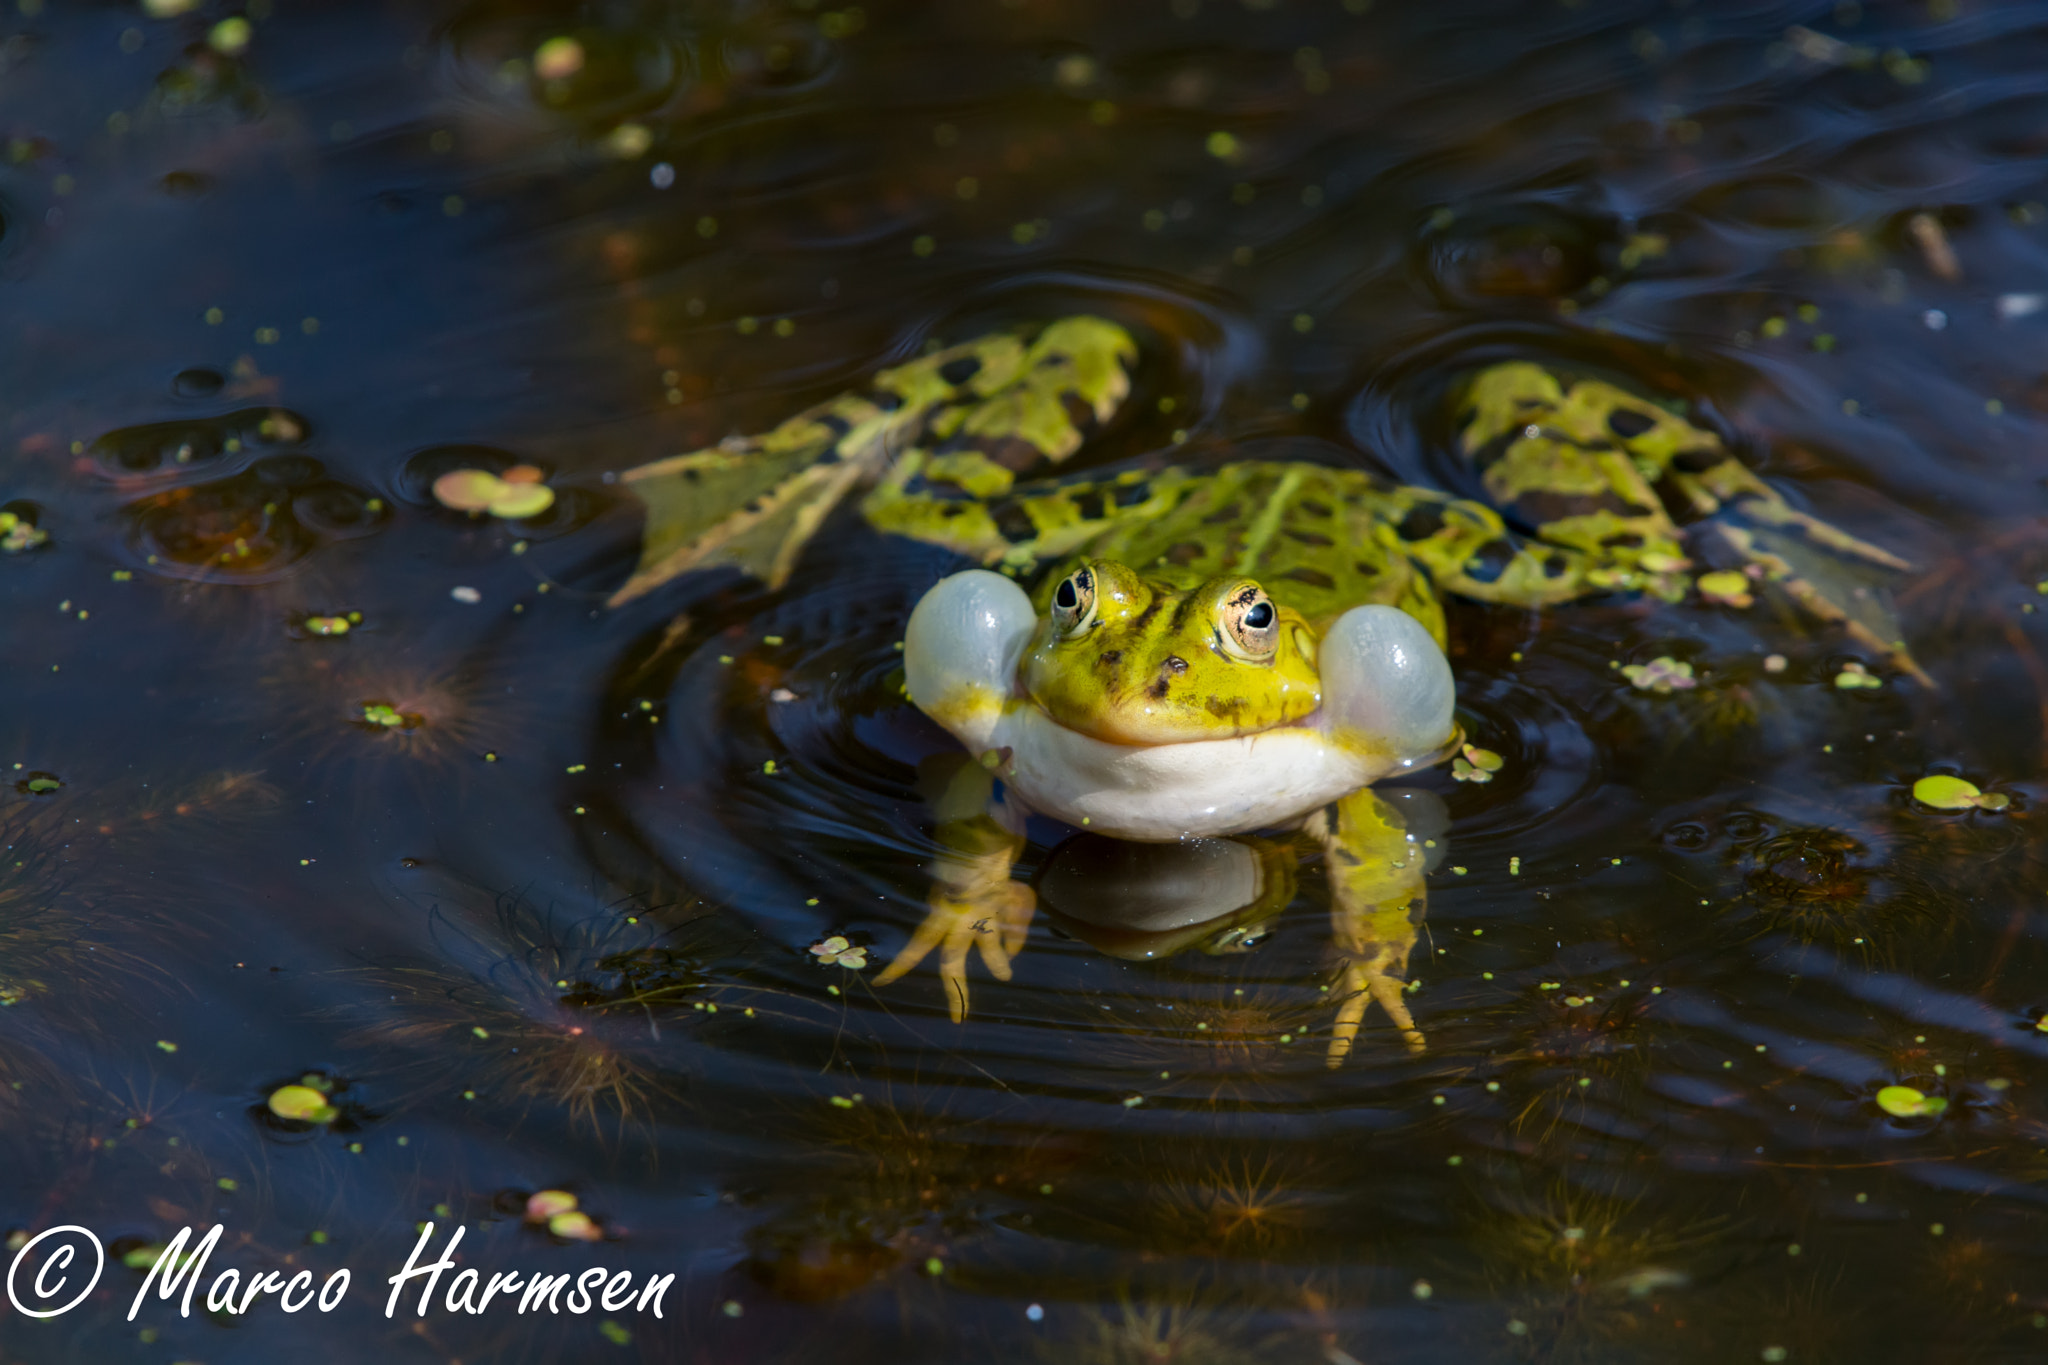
[{"x1": 874, "y1": 755, "x2": 1038, "y2": 1023}]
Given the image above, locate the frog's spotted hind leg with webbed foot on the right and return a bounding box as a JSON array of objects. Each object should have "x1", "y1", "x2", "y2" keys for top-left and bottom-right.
[{"x1": 1460, "y1": 362, "x2": 1929, "y2": 684}]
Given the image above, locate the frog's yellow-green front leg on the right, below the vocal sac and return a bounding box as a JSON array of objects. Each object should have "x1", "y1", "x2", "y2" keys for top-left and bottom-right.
[{"x1": 1309, "y1": 788, "x2": 1425, "y2": 1066}]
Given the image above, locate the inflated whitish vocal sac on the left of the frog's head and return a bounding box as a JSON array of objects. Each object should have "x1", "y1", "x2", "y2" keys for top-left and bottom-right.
[{"x1": 903, "y1": 569, "x2": 1038, "y2": 751}]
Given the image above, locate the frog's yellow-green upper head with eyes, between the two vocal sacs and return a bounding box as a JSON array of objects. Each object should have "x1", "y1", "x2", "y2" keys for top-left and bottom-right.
[{"x1": 1020, "y1": 559, "x2": 1323, "y2": 745}]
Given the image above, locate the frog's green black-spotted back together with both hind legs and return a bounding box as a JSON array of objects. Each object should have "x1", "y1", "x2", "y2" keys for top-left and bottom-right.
[{"x1": 612, "y1": 317, "x2": 1927, "y2": 681}]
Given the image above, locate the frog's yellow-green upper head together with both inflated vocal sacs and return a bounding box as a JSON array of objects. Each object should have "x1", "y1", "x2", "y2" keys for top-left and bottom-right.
[{"x1": 903, "y1": 561, "x2": 1454, "y2": 765}]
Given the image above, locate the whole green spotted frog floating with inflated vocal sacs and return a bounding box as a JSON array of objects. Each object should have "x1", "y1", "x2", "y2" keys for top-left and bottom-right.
[{"x1": 612, "y1": 315, "x2": 1931, "y2": 1066}]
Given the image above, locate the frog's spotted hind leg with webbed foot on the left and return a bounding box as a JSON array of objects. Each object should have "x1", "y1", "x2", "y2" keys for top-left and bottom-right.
[{"x1": 612, "y1": 317, "x2": 1137, "y2": 606}]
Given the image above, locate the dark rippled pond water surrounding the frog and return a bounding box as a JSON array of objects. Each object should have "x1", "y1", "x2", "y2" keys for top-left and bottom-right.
[{"x1": 0, "y1": 0, "x2": 2048, "y2": 1365}]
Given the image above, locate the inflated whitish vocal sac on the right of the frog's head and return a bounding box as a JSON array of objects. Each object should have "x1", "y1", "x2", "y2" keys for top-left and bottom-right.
[{"x1": 1317, "y1": 606, "x2": 1456, "y2": 765}]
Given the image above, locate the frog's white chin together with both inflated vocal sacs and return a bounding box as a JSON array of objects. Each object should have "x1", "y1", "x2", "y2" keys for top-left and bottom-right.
[{"x1": 903, "y1": 569, "x2": 1452, "y2": 841}]
